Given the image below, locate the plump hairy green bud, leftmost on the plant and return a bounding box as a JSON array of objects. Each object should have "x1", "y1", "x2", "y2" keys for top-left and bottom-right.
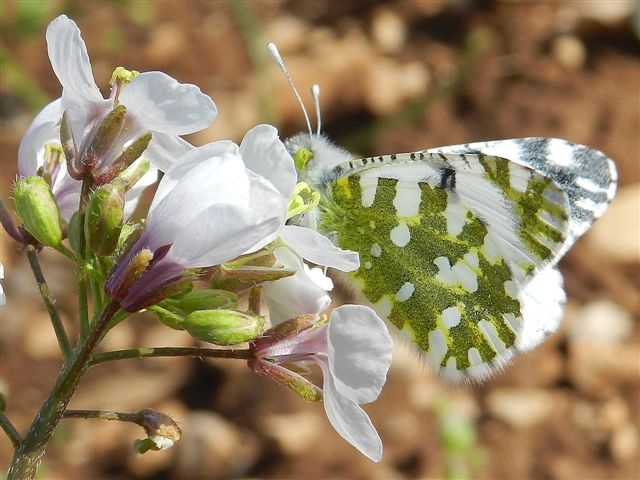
[{"x1": 13, "y1": 176, "x2": 62, "y2": 247}]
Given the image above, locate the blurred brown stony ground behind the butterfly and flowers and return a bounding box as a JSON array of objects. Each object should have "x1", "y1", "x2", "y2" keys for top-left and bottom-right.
[{"x1": 0, "y1": 0, "x2": 640, "y2": 480}]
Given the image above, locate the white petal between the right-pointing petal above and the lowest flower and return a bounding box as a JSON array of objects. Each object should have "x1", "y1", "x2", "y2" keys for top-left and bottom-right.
[{"x1": 263, "y1": 247, "x2": 331, "y2": 325}]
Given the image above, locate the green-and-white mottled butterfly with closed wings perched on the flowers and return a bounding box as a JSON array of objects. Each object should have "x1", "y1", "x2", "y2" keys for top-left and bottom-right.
[{"x1": 268, "y1": 45, "x2": 617, "y2": 381}]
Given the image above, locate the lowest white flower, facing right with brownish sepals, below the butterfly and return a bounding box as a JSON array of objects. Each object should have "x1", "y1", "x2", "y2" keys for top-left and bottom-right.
[{"x1": 249, "y1": 305, "x2": 392, "y2": 462}]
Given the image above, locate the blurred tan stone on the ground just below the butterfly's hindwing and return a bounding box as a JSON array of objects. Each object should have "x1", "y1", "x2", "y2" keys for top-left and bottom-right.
[{"x1": 486, "y1": 388, "x2": 559, "y2": 429}]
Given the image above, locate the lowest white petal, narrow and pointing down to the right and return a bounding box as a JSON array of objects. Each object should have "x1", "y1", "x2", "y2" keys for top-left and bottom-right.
[{"x1": 322, "y1": 367, "x2": 382, "y2": 462}]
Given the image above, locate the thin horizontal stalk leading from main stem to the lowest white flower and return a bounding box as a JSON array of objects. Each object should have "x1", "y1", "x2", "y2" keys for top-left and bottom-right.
[{"x1": 89, "y1": 347, "x2": 252, "y2": 366}]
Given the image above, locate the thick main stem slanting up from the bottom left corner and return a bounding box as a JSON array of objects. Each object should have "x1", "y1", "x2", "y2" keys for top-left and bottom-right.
[{"x1": 7, "y1": 301, "x2": 120, "y2": 480}]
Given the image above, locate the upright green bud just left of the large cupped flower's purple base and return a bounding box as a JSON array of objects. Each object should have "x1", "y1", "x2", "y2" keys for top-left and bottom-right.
[{"x1": 84, "y1": 184, "x2": 124, "y2": 255}]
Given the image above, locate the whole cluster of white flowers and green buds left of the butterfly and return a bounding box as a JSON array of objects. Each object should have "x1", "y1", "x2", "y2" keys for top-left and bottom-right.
[{"x1": 0, "y1": 15, "x2": 391, "y2": 468}]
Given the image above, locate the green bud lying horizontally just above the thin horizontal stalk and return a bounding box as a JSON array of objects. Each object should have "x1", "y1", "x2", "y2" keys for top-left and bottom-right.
[{"x1": 183, "y1": 310, "x2": 265, "y2": 345}]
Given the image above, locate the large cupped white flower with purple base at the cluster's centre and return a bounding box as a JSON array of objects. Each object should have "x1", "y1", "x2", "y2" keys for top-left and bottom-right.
[{"x1": 105, "y1": 141, "x2": 286, "y2": 311}]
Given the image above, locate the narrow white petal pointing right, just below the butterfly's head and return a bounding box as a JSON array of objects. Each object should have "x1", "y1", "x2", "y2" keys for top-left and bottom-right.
[{"x1": 282, "y1": 225, "x2": 360, "y2": 272}]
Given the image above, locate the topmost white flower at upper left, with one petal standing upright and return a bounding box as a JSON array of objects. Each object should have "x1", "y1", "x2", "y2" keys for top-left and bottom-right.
[{"x1": 18, "y1": 15, "x2": 216, "y2": 220}]
